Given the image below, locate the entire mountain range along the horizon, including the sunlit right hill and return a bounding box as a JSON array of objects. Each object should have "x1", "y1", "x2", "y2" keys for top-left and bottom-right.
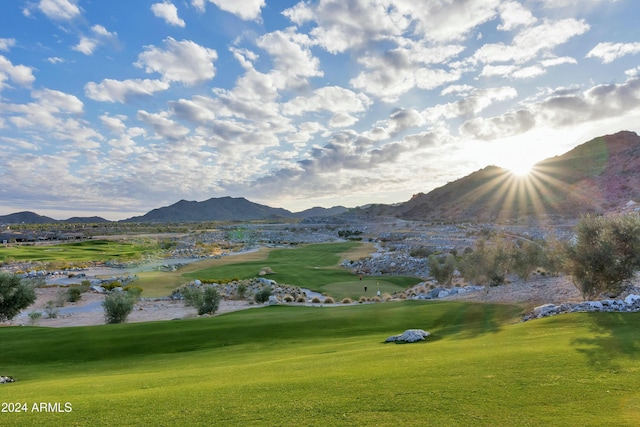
[{"x1": 0, "y1": 131, "x2": 640, "y2": 224}]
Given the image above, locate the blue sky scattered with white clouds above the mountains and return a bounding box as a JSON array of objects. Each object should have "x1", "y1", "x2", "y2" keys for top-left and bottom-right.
[{"x1": 0, "y1": 0, "x2": 640, "y2": 220}]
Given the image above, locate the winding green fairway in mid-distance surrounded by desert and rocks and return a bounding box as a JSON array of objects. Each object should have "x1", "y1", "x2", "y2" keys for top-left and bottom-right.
[{"x1": 183, "y1": 242, "x2": 420, "y2": 299}]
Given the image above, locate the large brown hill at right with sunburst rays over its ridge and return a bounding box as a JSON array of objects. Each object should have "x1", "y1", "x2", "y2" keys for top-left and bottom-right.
[{"x1": 380, "y1": 131, "x2": 640, "y2": 221}]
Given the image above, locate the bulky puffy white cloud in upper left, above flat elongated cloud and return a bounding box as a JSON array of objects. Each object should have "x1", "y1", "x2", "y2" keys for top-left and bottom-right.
[{"x1": 135, "y1": 37, "x2": 218, "y2": 86}]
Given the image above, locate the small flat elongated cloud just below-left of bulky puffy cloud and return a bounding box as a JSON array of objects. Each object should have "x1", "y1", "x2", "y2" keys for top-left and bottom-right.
[{"x1": 84, "y1": 79, "x2": 169, "y2": 103}]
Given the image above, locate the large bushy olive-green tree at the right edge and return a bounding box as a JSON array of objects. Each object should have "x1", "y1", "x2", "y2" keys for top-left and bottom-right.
[{"x1": 567, "y1": 215, "x2": 640, "y2": 299}]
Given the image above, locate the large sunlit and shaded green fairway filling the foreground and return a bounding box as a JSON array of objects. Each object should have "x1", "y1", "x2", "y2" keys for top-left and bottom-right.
[{"x1": 0, "y1": 301, "x2": 640, "y2": 426}]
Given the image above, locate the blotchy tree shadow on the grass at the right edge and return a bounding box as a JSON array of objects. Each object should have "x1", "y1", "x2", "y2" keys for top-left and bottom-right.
[{"x1": 572, "y1": 313, "x2": 640, "y2": 370}]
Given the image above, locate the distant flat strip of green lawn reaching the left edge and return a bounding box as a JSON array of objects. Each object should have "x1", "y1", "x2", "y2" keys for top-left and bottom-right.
[{"x1": 0, "y1": 240, "x2": 156, "y2": 262}]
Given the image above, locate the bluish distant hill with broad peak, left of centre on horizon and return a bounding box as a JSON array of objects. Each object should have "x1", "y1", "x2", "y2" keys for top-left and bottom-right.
[{"x1": 121, "y1": 197, "x2": 293, "y2": 222}]
